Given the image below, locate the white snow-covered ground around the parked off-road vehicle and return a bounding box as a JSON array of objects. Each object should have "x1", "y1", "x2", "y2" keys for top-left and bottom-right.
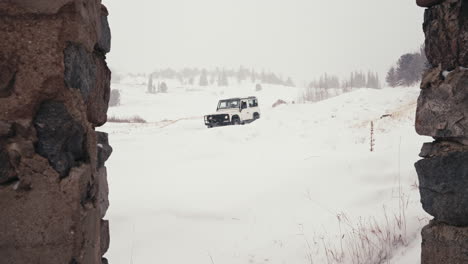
[{"x1": 101, "y1": 81, "x2": 429, "y2": 264}]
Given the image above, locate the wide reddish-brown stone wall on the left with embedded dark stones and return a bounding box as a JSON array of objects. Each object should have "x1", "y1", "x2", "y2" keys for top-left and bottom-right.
[{"x1": 0, "y1": 0, "x2": 112, "y2": 264}]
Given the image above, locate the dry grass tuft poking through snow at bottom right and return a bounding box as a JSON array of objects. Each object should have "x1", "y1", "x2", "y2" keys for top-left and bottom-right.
[{"x1": 314, "y1": 187, "x2": 409, "y2": 264}]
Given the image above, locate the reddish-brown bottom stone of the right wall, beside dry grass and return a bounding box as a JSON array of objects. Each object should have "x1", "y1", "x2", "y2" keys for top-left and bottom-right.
[{"x1": 421, "y1": 221, "x2": 468, "y2": 264}]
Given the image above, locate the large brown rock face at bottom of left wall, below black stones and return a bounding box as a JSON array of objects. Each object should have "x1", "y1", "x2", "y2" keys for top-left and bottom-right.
[{"x1": 0, "y1": 166, "x2": 100, "y2": 264}]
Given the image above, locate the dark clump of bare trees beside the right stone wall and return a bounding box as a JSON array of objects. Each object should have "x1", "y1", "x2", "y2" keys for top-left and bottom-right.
[{"x1": 385, "y1": 46, "x2": 428, "y2": 87}]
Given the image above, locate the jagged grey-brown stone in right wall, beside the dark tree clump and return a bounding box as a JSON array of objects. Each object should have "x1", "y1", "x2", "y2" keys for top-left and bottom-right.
[{"x1": 416, "y1": 68, "x2": 468, "y2": 140}]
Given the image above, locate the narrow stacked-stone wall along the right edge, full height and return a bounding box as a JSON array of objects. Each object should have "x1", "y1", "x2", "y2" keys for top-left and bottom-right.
[{"x1": 416, "y1": 0, "x2": 468, "y2": 264}]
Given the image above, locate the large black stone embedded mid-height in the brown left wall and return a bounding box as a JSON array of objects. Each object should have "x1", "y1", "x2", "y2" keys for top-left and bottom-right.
[{"x1": 34, "y1": 101, "x2": 87, "y2": 177}]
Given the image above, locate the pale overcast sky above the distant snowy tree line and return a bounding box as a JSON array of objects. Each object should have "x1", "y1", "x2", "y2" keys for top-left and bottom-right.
[{"x1": 103, "y1": 0, "x2": 424, "y2": 81}]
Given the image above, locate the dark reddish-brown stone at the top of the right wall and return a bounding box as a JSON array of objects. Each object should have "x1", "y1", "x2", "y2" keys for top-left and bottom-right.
[{"x1": 423, "y1": 0, "x2": 468, "y2": 70}]
